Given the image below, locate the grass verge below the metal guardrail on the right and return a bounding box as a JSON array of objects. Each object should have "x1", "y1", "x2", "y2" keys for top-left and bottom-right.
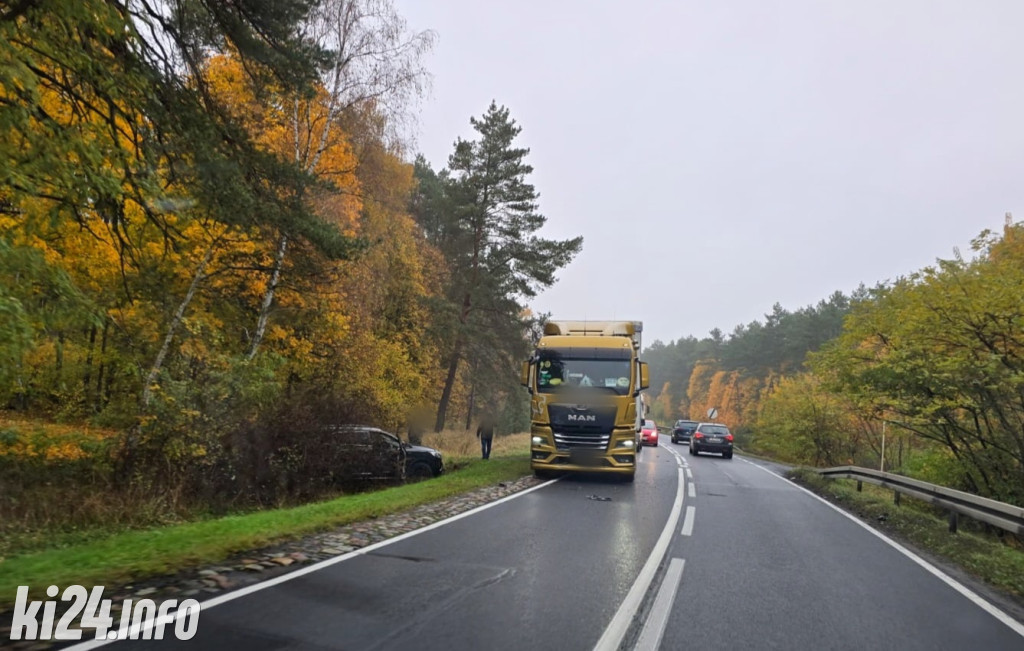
[{"x1": 787, "y1": 468, "x2": 1024, "y2": 598}]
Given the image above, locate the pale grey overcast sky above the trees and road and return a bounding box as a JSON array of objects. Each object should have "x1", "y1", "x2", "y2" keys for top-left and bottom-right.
[{"x1": 395, "y1": 0, "x2": 1024, "y2": 345}]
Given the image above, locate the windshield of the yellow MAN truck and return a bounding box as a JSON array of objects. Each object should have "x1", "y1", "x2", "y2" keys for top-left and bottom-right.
[{"x1": 537, "y1": 349, "x2": 630, "y2": 395}]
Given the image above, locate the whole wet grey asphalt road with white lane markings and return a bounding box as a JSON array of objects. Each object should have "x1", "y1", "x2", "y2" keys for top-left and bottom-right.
[{"x1": 81, "y1": 437, "x2": 1024, "y2": 650}]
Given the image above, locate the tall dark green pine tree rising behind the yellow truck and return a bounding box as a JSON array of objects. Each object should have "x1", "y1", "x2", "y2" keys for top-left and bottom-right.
[{"x1": 417, "y1": 101, "x2": 583, "y2": 431}]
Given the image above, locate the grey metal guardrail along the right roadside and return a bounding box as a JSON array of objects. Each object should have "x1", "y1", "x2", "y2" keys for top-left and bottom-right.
[{"x1": 816, "y1": 466, "x2": 1024, "y2": 535}]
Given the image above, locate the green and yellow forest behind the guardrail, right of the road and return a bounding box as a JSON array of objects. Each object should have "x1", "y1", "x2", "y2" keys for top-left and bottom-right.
[{"x1": 645, "y1": 215, "x2": 1024, "y2": 505}]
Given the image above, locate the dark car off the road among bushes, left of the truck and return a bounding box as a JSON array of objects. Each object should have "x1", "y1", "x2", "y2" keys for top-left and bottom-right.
[{"x1": 331, "y1": 425, "x2": 444, "y2": 481}]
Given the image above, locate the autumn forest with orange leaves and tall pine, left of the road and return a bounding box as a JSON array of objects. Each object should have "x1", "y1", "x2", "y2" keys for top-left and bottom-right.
[{"x1": 0, "y1": 0, "x2": 583, "y2": 520}]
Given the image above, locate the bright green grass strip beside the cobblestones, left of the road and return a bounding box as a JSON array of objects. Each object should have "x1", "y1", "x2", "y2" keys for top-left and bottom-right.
[{"x1": 0, "y1": 454, "x2": 530, "y2": 605}]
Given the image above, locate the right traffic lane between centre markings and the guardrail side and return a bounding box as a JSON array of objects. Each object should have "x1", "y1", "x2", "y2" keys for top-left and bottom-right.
[{"x1": 648, "y1": 447, "x2": 1024, "y2": 651}]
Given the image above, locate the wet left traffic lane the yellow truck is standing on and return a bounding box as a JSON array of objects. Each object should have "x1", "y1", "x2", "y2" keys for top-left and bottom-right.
[{"x1": 111, "y1": 448, "x2": 678, "y2": 651}]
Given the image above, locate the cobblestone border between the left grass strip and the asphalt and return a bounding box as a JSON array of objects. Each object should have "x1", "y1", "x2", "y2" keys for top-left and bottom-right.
[{"x1": 0, "y1": 475, "x2": 542, "y2": 651}]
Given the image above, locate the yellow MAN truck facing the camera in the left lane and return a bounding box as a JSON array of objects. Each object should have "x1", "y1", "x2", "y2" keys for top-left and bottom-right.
[{"x1": 520, "y1": 320, "x2": 650, "y2": 481}]
